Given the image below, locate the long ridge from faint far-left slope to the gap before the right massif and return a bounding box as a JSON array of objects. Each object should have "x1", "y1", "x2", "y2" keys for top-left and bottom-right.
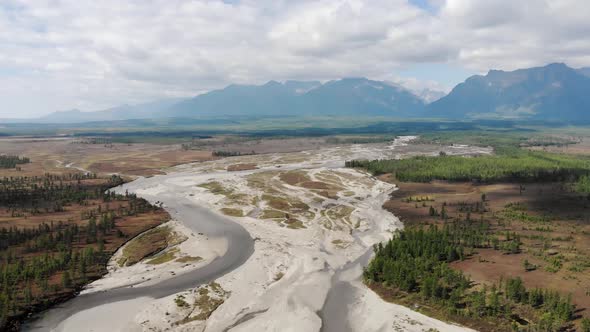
[{"x1": 23, "y1": 77, "x2": 425, "y2": 123}]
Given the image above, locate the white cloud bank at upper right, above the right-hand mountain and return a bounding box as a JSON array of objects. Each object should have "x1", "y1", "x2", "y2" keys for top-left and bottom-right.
[{"x1": 440, "y1": 0, "x2": 590, "y2": 71}]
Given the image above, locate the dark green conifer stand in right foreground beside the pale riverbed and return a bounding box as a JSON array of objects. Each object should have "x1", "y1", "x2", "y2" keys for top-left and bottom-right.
[{"x1": 363, "y1": 222, "x2": 575, "y2": 331}]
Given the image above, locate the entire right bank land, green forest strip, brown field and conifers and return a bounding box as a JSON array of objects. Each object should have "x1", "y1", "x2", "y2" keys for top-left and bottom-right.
[{"x1": 347, "y1": 137, "x2": 590, "y2": 331}]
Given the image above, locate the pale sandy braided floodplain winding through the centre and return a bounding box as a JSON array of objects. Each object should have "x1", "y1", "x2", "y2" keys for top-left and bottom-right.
[{"x1": 29, "y1": 137, "x2": 491, "y2": 331}]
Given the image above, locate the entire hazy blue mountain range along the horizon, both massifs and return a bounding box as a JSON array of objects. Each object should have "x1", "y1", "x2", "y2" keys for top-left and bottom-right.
[{"x1": 10, "y1": 63, "x2": 590, "y2": 123}]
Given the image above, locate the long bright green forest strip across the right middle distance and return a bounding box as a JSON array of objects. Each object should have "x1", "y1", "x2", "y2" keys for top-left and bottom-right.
[{"x1": 346, "y1": 150, "x2": 590, "y2": 182}]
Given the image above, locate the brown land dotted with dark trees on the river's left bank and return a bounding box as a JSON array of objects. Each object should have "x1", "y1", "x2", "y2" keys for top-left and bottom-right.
[{"x1": 0, "y1": 162, "x2": 169, "y2": 331}]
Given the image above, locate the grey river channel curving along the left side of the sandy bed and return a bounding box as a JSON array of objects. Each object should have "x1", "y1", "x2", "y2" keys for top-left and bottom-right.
[{"x1": 23, "y1": 175, "x2": 254, "y2": 331}]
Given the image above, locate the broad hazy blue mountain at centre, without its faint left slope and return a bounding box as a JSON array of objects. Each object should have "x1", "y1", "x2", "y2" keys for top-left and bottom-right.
[{"x1": 167, "y1": 78, "x2": 424, "y2": 117}]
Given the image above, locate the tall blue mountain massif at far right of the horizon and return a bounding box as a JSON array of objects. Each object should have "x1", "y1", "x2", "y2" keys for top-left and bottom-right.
[{"x1": 428, "y1": 62, "x2": 590, "y2": 121}]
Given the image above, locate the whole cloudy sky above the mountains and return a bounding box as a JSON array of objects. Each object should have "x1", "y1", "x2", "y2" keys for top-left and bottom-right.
[{"x1": 0, "y1": 0, "x2": 590, "y2": 118}]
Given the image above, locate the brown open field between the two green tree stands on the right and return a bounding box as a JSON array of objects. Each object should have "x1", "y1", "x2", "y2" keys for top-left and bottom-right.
[{"x1": 381, "y1": 176, "x2": 590, "y2": 326}]
